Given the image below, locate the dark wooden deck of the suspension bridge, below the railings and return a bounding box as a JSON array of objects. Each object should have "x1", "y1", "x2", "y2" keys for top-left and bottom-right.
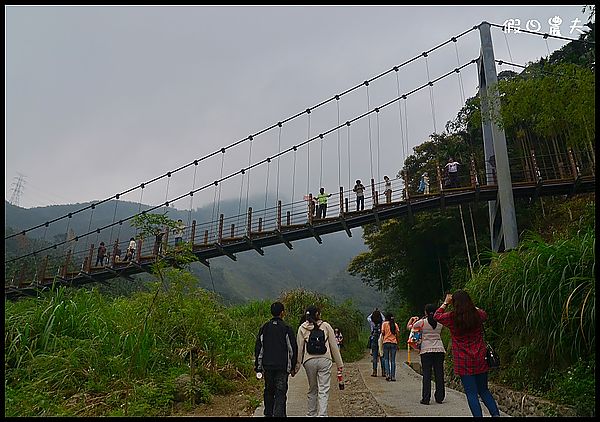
[{"x1": 5, "y1": 176, "x2": 595, "y2": 299}]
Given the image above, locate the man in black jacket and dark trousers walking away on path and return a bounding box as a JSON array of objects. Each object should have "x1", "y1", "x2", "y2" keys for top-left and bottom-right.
[{"x1": 254, "y1": 302, "x2": 298, "y2": 416}]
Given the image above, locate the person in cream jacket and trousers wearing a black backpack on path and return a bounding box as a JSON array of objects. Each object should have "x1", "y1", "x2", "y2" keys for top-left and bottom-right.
[{"x1": 296, "y1": 305, "x2": 344, "y2": 416}]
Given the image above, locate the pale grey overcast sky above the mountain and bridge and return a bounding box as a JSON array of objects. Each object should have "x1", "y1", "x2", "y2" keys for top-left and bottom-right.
[{"x1": 5, "y1": 5, "x2": 588, "y2": 213}]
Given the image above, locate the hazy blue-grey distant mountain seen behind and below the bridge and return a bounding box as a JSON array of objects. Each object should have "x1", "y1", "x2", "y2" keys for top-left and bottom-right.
[{"x1": 5, "y1": 200, "x2": 383, "y2": 312}]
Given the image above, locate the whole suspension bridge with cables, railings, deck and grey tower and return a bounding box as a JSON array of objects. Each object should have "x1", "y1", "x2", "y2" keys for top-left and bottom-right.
[{"x1": 5, "y1": 22, "x2": 595, "y2": 299}]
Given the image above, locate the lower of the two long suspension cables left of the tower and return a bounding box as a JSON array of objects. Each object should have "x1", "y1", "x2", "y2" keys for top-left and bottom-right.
[{"x1": 5, "y1": 59, "x2": 477, "y2": 263}]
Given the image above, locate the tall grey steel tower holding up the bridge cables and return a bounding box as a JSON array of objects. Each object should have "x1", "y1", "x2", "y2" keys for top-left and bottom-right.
[{"x1": 477, "y1": 22, "x2": 519, "y2": 252}]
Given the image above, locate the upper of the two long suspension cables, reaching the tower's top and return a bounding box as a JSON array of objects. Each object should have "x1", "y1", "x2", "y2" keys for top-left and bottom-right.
[{"x1": 4, "y1": 25, "x2": 479, "y2": 240}]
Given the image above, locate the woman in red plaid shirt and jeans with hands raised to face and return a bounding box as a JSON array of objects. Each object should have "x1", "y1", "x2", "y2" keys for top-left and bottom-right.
[{"x1": 433, "y1": 290, "x2": 500, "y2": 417}]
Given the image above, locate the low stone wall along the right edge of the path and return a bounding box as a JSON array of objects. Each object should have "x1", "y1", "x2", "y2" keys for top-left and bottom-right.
[{"x1": 406, "y1": 362, "x2": 577, "y2": 416}]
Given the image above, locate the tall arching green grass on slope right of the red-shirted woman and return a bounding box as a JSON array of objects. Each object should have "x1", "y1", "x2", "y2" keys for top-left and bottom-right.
[{"x1": 467, "y1": 226, "x2": 596, "y2": 368}]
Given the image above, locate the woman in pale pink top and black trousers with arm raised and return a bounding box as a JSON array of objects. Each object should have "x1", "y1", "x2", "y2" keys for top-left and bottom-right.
[{"x1": 406, "y1": 303, "x2": 446, "y2": 404}]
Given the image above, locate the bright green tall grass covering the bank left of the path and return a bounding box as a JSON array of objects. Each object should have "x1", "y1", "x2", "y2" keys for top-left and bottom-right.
[{"x1": 4, "y1": 269, "x2": 362, "y2": 416}]
